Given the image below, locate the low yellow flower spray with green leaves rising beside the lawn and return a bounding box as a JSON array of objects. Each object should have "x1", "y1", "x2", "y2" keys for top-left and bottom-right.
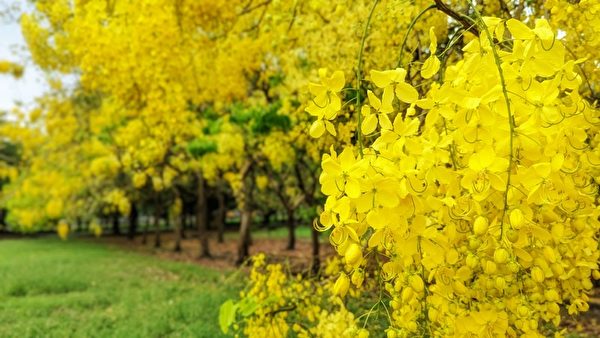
[{"x1": 227, "y1": 254, "x2": 369, "y2": 338}]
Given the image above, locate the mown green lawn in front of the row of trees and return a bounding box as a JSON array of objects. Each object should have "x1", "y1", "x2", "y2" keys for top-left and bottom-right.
[{"x1": 0, "y1": 239, "x2": 239, "y2": 338}]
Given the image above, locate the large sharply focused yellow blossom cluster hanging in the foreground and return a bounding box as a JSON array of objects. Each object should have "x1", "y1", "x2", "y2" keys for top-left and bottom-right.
[{"x1": 307, "y1": 17, "x2": 600, "y2": 337}]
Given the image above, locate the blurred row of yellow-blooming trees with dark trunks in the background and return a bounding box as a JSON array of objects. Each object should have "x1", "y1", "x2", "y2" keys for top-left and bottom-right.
[{"x1": 2, "y1": 0, "x2": 598, "y2": 270}]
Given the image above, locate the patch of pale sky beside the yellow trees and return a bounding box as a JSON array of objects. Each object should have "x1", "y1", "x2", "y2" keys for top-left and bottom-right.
[{"x1": 0, "y1": 0, "x2": 46, "y2": 117}]
